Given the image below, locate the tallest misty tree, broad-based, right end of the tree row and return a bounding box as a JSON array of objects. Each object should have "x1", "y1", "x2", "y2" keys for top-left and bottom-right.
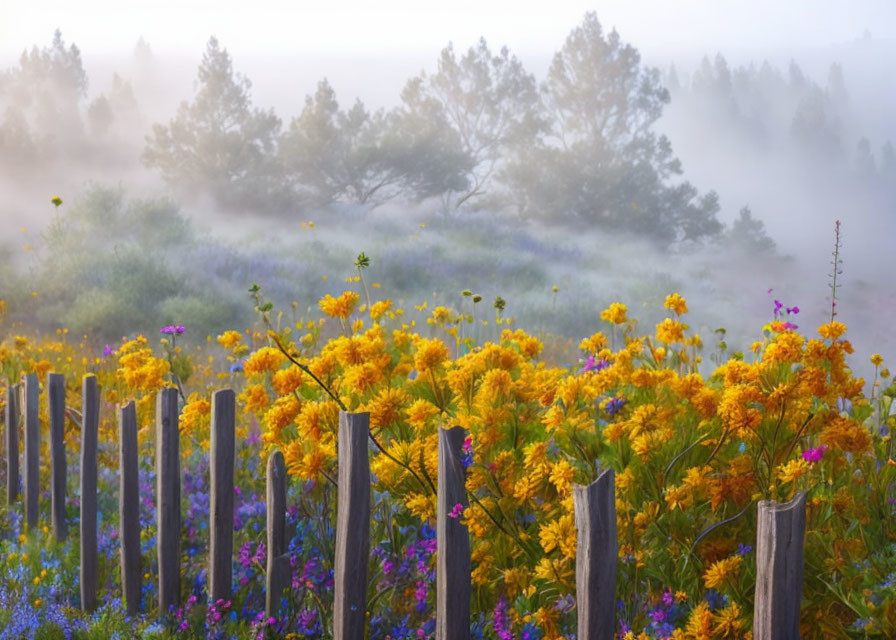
[{"x1": 511, "y1": 13, "x2": 721, "y2": 241}]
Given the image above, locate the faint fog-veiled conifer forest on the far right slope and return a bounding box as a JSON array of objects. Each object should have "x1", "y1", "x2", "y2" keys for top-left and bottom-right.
[{"x1": 663, "y1": 48, "x2": 896, "y2": 238}]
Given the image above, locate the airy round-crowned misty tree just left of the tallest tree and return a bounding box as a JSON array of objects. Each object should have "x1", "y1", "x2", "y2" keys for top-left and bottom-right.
[{"x1": 402, "y1": 39, "x2": 544, "y2": 208}]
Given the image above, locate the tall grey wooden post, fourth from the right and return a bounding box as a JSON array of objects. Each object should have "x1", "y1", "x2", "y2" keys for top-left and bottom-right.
[{"x1": 333, "y1": 411, "x2": 370, "y2": 640}]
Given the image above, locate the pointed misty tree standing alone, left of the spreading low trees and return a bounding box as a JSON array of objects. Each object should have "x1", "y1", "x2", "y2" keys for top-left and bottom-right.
[{"x1": 143, "y1": 37, "x2": 283, "y2": 208}]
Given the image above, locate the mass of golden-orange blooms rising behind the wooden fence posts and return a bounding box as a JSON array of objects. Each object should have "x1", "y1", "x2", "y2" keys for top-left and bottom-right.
[{"x1": 0, "y1": 292, "x2": 880, "y2": 639}]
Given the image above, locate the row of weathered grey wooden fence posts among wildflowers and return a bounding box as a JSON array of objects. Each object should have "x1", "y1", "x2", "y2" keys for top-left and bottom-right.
[{"x1": 5, "y1": 373, "x2": 806, "y2": 640}]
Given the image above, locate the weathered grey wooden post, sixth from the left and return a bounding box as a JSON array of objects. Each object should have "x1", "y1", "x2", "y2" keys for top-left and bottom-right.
[{"x1": 156, "y1": 387, "x2": 181, "y2": 615}]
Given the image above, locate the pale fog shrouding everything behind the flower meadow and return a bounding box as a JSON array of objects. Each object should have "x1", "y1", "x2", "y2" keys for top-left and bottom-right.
[{"x1": 0, "y1": 1, "x2": 896, "y2": 376}]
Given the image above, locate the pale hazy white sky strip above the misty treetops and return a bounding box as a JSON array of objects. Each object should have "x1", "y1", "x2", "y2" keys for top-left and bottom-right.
[{"x1": 0, "y1": 0, "x2": 896, "y2": 60}]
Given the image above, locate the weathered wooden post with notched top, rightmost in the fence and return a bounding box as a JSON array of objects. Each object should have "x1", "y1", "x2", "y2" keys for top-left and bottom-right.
[{"x1": 753, "y1": 492, "x2": 806, "y2": 640}]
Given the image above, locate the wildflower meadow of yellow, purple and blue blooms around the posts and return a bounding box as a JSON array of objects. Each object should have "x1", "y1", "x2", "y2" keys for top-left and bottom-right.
[{"x1": 0, "y1": 276, "x2": 896, "y2": 640}]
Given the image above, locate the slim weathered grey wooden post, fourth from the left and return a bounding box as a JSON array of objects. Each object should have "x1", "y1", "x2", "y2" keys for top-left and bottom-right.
[{"x1": 80, "y1": 375, "x2": 100, "y2": 611}]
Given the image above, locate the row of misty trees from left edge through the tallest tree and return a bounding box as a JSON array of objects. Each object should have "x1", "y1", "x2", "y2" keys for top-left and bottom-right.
[{"x1": 0, "y1": 13, "x2": 744, "y2": 242}]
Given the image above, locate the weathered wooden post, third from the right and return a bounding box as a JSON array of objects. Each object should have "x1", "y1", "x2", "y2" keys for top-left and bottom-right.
[{"x1": 436, "y1": 427, "x2": 471, "y2": 640}]
